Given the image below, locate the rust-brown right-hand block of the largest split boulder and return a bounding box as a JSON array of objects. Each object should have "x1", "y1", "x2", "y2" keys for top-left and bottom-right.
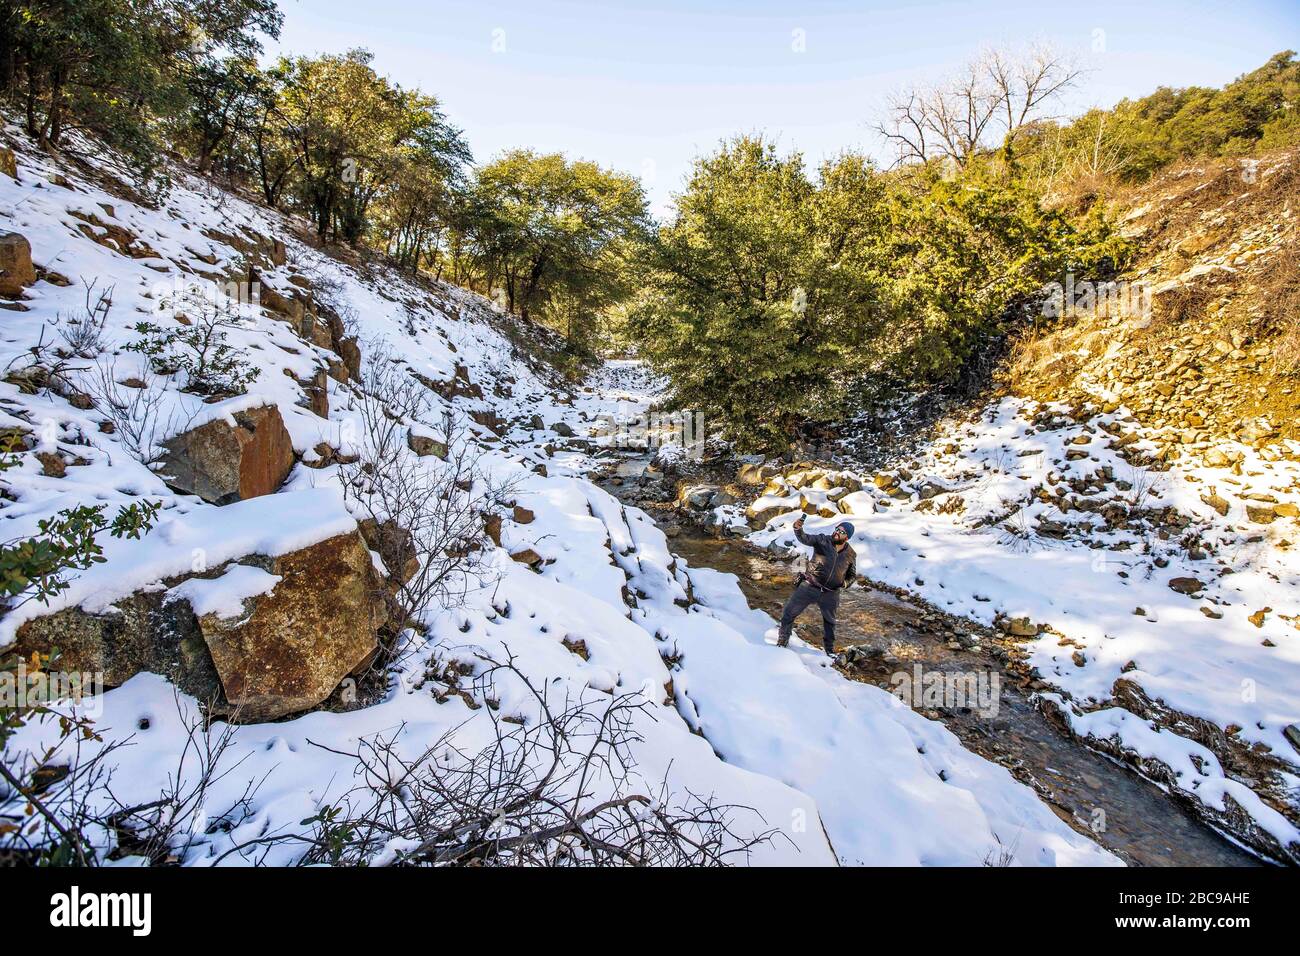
[{"x1": 198, "y1": 532, "x2": 387, "y2": 721}]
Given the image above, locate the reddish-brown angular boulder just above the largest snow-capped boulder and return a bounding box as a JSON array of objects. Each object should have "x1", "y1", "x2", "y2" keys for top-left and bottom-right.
[{"x1": 161, "y1": 405, "x2": 294, "y2": 505}]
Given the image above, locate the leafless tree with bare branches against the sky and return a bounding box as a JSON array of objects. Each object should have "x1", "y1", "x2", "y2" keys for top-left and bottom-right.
[{"x1": 876, "y1": 47, "x2": 1082, "y2": 165}]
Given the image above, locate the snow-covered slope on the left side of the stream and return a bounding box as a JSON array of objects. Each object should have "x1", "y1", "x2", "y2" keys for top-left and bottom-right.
[{"x1": 0, "y1": 133, "x2": 1118, "y2": 866}]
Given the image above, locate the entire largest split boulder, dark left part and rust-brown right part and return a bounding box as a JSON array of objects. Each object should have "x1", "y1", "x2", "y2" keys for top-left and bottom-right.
[{"x1": 5, "y1": 531, "x2": 387, "y2": 721}]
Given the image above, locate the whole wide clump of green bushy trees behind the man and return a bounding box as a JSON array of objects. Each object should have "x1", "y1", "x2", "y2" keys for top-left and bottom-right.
[{"x1": 627, "y1": 138, "x2": 1126, "y2": 450}]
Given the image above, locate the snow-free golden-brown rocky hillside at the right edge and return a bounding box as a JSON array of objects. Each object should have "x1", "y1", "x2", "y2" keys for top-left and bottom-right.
[{"x1": 1008, "y1": 151, "x2": 1300, "y2": 449}]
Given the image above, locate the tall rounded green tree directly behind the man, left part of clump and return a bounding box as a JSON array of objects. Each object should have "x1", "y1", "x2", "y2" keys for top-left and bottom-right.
[{"x1": 629, "y1": 137, "x2": 888, "y2": 447}]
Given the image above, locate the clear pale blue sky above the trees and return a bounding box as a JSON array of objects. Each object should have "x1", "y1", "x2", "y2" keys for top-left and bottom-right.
[{"x1": 268, "y1": 0, "x2": 1300, "y2": 212}]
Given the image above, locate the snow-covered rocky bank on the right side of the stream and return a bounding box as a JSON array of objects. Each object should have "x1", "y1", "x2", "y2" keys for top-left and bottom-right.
[{"x1": 743, "y1": 398, "x2": 1300, "y2": 847}]
